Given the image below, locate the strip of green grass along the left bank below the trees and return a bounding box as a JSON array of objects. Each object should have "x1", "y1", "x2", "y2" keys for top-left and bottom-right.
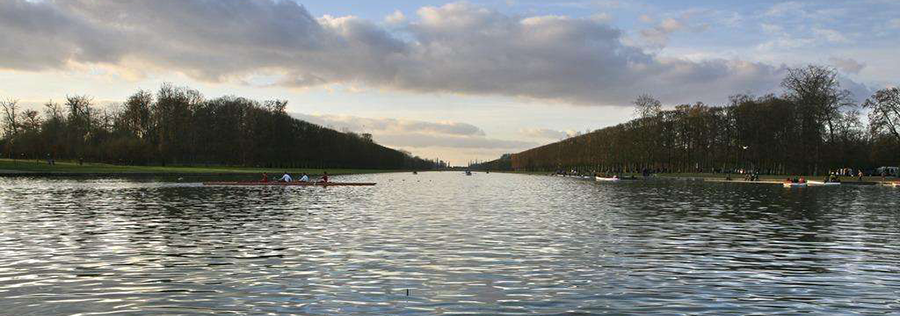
[{"x1": 0, "y1": 159, "x2": 398, "y2": 177}]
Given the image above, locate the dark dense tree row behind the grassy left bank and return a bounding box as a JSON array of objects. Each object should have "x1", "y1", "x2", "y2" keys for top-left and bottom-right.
[{"x1": 0, "y1": 84, "x2": 435, "y2": 169}]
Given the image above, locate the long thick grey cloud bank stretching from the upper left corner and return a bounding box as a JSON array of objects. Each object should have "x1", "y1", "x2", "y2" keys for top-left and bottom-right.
[{"x1": 0, "y1": 0, "x2": 808, "y2": 105}]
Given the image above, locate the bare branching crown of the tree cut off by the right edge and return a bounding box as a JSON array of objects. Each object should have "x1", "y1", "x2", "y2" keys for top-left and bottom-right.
[{"x1": 863, "y1": 87, "x2": 900, "y2": 142}]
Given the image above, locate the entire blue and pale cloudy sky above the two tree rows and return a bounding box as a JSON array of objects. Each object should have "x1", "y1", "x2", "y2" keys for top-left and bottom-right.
[{"x1": 0, "y1": 0, "x2": 900, "y2": 165}]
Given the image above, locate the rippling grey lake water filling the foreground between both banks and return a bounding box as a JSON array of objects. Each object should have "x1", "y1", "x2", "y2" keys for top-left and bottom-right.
[{"x1": 0, "y1": 172, "x2": 900, "y2": 316}]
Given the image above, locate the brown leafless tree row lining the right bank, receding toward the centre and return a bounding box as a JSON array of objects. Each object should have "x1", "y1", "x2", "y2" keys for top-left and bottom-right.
[{"x1": 477, "y1": 65, "x2": 900, "y2": 175}]
